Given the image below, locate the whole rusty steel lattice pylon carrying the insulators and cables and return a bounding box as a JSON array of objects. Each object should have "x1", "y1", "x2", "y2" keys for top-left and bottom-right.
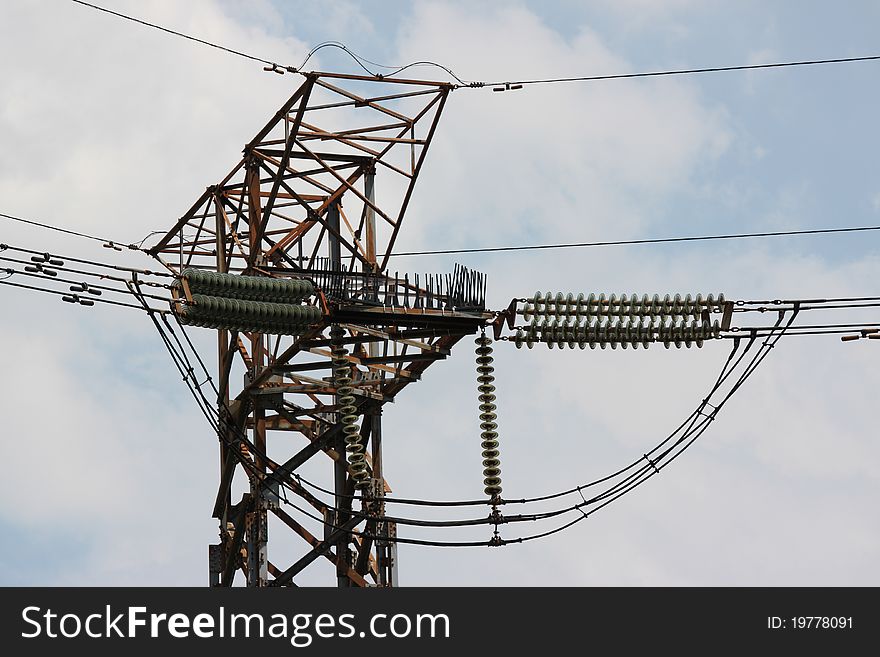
[{"x1": 150, "y1": 73, "x2": 491, "y2": 586}]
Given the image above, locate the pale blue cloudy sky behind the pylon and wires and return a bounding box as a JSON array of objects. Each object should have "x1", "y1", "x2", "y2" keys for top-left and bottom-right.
[{"x1": 0, "y1": 0, "x2": 880, "y2": 586}]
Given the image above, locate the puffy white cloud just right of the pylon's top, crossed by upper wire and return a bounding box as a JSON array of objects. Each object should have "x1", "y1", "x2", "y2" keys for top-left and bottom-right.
[{"x1": 401, "y1": 3, "x2": 730, "y2": 254}]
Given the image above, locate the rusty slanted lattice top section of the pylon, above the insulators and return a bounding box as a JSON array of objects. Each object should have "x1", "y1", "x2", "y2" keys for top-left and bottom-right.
[{"x1": 151, "y1": 73, "x2": 451, "y2": 272}]
